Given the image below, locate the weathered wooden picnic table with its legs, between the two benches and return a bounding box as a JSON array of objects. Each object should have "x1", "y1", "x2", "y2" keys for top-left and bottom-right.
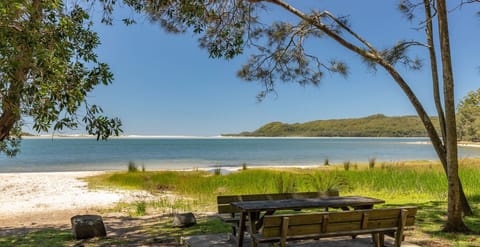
[{"x1": 231, "y1": 196, "x2": 385, "y2": 246}]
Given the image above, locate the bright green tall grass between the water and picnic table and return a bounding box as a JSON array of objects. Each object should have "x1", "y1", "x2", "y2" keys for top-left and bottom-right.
[{"x1": 86, "y1": 160, "x2": 480, "y2": 243}]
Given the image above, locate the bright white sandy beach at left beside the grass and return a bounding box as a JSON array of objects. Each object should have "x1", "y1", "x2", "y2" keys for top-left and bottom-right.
[{"x1": 0, "y1": 172, "x2": 152, "y2": 228}]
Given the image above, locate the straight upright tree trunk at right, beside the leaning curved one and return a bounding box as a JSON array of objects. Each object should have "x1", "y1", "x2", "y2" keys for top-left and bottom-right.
[{"x1": 437, "y1": 0, "x2": 468, "y2": 232}]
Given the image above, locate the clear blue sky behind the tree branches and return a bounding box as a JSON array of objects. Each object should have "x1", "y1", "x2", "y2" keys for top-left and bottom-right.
[{"x1": 80, "y1": 0, "x2": 480, "y2": 136}]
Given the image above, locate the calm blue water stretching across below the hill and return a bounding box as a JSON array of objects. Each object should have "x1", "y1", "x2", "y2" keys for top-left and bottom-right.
[{"x1": 0, "y1": 138, "x2": 480, "y2": 172}]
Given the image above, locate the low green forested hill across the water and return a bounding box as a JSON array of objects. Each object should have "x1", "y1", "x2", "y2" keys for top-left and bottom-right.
[{"x1": 225, "y1": 114, "x2": 438, "y2": 137}]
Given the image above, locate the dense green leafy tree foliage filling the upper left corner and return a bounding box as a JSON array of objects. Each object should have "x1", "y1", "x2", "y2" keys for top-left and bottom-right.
[{"x1": 0, "y1": 0, "x2": 121, "y2": 155}]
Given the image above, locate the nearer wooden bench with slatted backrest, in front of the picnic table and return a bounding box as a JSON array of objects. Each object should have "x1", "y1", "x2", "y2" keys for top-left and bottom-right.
[{"x1": 252, "y1": 207, "x2": 417, "y2": 247}]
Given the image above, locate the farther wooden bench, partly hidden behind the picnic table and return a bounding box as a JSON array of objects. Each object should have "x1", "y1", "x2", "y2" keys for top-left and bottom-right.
[{"x1": 217, "y1": 191, "x2": 339, "y2": 239}]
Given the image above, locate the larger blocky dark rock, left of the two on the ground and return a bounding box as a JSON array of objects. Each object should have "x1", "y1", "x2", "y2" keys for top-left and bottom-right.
[{"x1": 70, "y1": 215, "x2": 107, "y2": 240}]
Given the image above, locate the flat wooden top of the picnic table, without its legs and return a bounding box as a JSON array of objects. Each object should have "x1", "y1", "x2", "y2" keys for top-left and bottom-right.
[{"x1": 231, "y1": 196, "x2": 385, "y2": 212}]
